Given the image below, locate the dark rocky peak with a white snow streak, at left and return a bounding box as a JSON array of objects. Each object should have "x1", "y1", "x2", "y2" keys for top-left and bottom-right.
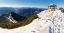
[{"x1": 0, "y1": 12, "x2": 25, "y2": 24}]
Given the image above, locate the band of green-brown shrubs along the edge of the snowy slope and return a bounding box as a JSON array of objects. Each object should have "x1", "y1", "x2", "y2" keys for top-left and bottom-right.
[{"x1": 0, "y1": 14, "x2": 38, "y2": 29}]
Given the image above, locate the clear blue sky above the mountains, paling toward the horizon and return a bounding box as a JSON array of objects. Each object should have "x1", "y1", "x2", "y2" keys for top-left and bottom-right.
[{"x1": 0, "y1": 0, "x2": 64, "y2": 8}]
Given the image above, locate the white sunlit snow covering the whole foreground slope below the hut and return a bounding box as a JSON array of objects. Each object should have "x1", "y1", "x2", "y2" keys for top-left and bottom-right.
[{"x1": 0, "y1": 10, "x2": 64, "y2": 33}]
